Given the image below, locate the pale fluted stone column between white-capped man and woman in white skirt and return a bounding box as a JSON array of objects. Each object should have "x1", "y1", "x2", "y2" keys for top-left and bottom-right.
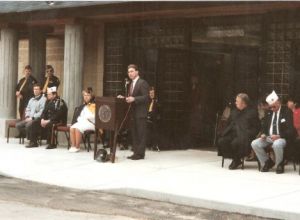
[{"x1": 63, "y1": 24, "x2": 84, "y2": 121}]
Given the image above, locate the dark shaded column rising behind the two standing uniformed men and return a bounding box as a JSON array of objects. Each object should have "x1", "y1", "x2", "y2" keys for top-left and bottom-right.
[{"x1": 29, "y1": 29, "x2": 46, "y2": 83}]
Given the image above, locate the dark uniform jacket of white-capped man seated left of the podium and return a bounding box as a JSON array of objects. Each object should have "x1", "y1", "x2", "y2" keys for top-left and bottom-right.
[{"x1": 41, "y1": 97, "x2": 68, "y2": 124}]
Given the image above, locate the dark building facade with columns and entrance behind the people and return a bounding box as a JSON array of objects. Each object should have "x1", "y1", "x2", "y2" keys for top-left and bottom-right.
[{"x1": 0, "y1": 2, "x2": 300, "y2": 148}]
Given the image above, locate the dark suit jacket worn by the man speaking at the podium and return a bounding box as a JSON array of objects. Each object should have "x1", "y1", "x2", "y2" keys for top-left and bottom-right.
[{"x1": 131, "y1": 78, "x2": 149, "y2": 118}]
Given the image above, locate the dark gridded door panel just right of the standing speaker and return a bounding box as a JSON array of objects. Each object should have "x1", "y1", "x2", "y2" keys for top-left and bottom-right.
[{"x1": 157, "y1": 49, "x2": 190, "y2": 148}]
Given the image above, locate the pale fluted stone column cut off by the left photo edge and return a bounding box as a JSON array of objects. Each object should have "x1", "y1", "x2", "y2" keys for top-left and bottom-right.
[{"x1": 0, "y1": 28, "x2": 19, "y2": 137}]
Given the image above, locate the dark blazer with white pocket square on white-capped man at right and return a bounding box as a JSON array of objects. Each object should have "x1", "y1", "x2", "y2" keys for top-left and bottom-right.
[{"x1": 262, "y1": 106, "x2": 296, "y2": 141}]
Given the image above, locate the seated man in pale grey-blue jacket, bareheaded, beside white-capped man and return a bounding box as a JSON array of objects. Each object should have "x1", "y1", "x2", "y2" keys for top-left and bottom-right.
[{"x1": 16, "y1": 84, "x2": 46, "y2": 140}]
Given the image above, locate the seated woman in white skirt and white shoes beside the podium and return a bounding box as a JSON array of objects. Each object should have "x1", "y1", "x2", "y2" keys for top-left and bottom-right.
[{"x1": 69, "y1": 87, "x2": 96, "y2": 153}]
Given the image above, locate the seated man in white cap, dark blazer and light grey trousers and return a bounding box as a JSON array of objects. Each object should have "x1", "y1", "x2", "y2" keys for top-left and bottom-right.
[{"x1": 251, "y1": 91, "x2": 295, "y2": 174}]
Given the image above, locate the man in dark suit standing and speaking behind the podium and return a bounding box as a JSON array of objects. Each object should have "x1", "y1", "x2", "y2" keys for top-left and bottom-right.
[{"x1": 126, "y1": 64, "x2": 149, "y2": 160}]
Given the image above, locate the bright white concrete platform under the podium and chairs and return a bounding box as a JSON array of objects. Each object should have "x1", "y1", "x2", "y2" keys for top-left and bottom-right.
[{"x1": 0, "y1": 138, "x2": 300, "y2": 220}]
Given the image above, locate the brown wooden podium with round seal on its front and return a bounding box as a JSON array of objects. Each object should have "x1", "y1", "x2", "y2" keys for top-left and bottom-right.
[{"x1": 94, "y1": 97, "x2": 129, "y2": 163}]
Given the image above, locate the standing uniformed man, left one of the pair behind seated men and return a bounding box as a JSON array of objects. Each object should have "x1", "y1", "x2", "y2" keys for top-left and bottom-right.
[{"x1": 16, "y1": 65, "x2": 37, "y2": 118}]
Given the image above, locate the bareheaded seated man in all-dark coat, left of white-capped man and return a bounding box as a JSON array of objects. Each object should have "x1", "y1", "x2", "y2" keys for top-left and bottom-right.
[{"x1": 218, "y1": 93, "x2": 259, "y2": 170}]
